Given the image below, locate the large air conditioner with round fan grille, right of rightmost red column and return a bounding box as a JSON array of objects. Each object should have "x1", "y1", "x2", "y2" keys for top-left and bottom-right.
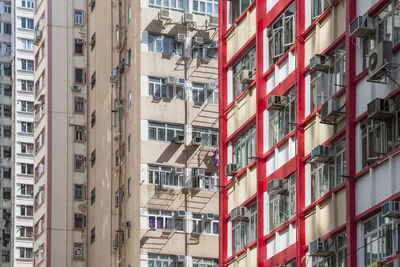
[{"x1": 368, "y1": 40, "x2": 393, "y2": 81}]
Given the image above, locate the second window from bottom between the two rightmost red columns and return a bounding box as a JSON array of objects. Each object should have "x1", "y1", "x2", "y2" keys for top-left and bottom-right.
[{"x1": 311, "y1": 139, "x2": 346, "y2": 201}]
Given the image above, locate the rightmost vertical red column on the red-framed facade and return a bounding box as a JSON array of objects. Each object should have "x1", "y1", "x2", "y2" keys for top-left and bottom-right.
[{"x1": 346, "y1": 0, "x2": 357, "y2": 266}]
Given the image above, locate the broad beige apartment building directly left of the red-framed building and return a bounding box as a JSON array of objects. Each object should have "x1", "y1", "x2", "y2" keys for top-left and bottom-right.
[{"x1": 86, "y1": 0, "x2": 219, "y2": 267}]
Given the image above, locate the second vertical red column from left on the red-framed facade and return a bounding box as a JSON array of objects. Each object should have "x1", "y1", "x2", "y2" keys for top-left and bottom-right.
[{"x1": 256, "y1": 0, "x2": 267, "y2": 267}]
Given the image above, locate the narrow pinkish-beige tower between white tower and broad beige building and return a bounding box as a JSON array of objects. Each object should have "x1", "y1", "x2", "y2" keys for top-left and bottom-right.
[{"x1": 33, "y1": 0, "x2": 87, "y2": 267}]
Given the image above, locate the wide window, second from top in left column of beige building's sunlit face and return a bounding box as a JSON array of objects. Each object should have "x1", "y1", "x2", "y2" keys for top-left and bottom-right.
[{"x1": 148, "y1": 33, "x2": 184, "y2": 56}]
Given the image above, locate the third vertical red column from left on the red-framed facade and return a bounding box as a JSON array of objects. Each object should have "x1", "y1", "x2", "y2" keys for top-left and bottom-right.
[{"x1": 296, "y1": 0, "x2": 308, "y2": 266}]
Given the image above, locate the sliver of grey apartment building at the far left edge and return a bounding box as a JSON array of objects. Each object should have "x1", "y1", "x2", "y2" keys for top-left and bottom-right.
[{"x1": 0, "y1": 1, "x2": 13, "y2": 266}]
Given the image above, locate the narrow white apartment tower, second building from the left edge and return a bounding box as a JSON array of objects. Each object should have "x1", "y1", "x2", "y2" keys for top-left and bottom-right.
[{"x1": 11, "y1": 0, "x2": 35, "y2": 267}]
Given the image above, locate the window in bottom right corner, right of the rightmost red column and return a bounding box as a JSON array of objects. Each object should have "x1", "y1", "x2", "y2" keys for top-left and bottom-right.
[{"x1": 363, "y1": 214, "x2": 400, "y2": 266}]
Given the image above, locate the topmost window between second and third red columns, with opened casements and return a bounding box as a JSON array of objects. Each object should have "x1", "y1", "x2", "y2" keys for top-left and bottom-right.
[{"x1": 267, "y1": 3, "x2": 295, "y2": 65}]
